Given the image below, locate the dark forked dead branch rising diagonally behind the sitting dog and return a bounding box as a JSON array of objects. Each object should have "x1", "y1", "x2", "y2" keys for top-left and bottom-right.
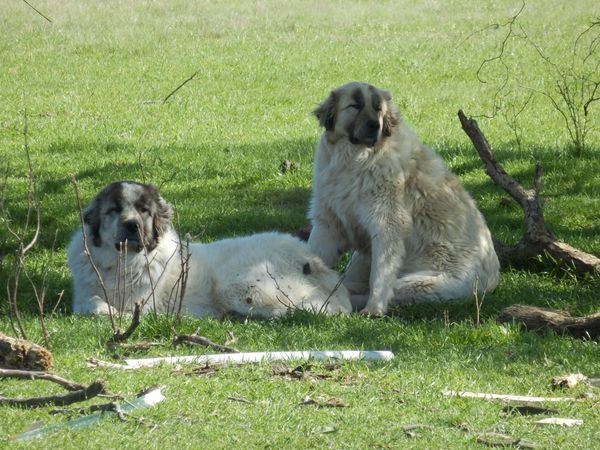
[{"x1": 458, "y1": 110, "x2": 600, "y2": 275}]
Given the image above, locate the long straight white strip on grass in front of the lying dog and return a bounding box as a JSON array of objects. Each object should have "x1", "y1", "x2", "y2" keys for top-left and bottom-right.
[{"x1": 88, "y1": 350, "x2": 394, "y2": 370}]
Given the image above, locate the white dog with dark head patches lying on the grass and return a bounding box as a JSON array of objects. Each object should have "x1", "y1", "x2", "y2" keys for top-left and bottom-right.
[{"x1": 68, "y1": 181, "x2": 351, "y2": 318}]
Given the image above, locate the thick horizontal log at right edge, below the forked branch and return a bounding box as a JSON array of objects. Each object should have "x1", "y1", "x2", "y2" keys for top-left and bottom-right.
[{"x1": 496, "y1": 304, "x2": 600, "y2": 339}]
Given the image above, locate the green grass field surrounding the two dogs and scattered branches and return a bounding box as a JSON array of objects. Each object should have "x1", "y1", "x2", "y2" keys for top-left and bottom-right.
[{"x1": 0, "y1": 0, "x2": 600, "y2": 449}]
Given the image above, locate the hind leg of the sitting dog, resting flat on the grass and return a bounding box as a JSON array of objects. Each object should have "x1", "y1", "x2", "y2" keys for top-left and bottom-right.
[{"x1": 391, "y1": 271, "x2": 477, "y2": 306}]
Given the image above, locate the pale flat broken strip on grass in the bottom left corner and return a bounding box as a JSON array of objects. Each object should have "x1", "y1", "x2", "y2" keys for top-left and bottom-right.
[{"x1": 13, "y1": 387, "x2": 165, "y2": 441}]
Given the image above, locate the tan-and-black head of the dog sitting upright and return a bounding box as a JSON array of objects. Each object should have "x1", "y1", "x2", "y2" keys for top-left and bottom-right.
[{"x1": 313, "y1": 82, "x2": 400, "y2": 147}]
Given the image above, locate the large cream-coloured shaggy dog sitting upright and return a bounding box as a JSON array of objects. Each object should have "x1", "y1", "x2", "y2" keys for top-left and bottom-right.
[{"x1": 308, "y1": 82, "x2": 499, "y2": 315}]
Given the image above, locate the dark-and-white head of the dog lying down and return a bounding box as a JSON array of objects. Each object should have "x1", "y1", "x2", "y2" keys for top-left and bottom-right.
[{"x1": 83, "y1": 181, "x2": 172, "y2": 253}]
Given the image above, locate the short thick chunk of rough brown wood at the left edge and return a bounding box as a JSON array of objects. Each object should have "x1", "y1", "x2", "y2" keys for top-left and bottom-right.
[{"x1": 0, "y1": 333, "x2": 52, "y2": 371}]
